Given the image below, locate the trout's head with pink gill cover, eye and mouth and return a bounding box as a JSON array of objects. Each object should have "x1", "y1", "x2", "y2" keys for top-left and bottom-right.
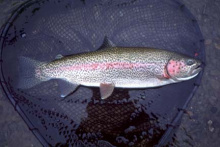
[{"x1": 166, "y1": 55, "x2": 202, "y2": 81}]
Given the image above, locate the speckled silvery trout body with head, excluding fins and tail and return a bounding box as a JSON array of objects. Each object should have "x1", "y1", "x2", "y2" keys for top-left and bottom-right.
[{"x1": 36, "y1": 47, "x2": 201, "y2": 88}]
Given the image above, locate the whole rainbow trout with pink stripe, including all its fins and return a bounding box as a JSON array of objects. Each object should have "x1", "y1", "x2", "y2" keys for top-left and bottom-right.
[{"x1": 17, "y1": 40, "x2": 202, "y2": 99}]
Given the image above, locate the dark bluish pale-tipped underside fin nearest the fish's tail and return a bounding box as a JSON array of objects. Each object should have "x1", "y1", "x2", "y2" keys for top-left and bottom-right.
[{"x1": 57, "y1": 79, "x2": 79, "y2": 98}]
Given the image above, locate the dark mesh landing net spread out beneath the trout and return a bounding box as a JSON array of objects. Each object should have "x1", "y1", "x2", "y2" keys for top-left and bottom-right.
[{"x1": 0, "y1": 0, "x2": 205, "y2": 147}]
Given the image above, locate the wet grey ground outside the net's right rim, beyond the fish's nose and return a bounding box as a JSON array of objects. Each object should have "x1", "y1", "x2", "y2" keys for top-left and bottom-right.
[{"x1": 175, "y1": 0, "x2": 220, "y2": 147}]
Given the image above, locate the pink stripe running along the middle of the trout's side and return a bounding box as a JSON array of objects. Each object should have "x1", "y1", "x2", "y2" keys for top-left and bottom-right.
[{"x1": 58, "y1": 62, "x2": 156, "y2": 71}]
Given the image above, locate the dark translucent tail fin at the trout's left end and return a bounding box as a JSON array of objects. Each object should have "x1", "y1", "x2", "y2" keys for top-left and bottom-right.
[{"x1": 17, "y1": 57, "x2": 44, "y2": 89}]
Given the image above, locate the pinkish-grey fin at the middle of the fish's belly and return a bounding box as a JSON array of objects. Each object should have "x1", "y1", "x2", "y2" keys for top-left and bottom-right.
[{"x1": 100, "y1": 83, "x2": 115, "y2": 99}]
